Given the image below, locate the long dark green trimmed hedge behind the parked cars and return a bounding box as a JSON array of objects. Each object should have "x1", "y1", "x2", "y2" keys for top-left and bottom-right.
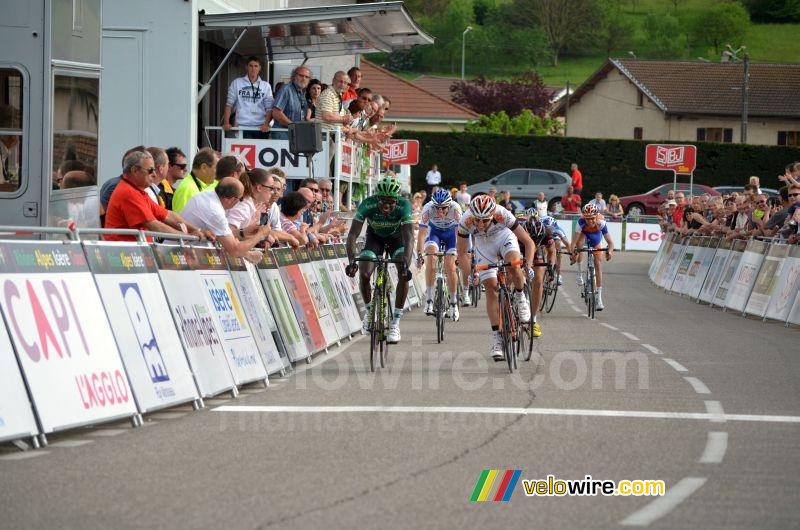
[{"x1": 398, "y1": 131, "x2": 800, "y2": 197}]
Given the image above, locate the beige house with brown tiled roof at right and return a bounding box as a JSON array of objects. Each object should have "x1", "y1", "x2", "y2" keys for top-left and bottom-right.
[{"x1": 556, "y1": 59, "x2": 800, "y2": 145}]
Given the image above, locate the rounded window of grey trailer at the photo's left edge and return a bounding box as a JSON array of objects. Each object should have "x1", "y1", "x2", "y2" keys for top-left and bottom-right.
[{"x1": 0, "y1": 68, "x2": 27, "y2": 193}]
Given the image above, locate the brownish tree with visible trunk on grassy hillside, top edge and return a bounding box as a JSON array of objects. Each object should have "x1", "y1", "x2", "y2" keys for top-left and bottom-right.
[{"x1": 514, "y1": 0, "x2": 599, "y2": 66}]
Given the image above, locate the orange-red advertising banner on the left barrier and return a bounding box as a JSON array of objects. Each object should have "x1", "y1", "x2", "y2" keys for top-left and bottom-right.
[{"x1": 273, "y1": 248, "x2": 327, "y2": 353}]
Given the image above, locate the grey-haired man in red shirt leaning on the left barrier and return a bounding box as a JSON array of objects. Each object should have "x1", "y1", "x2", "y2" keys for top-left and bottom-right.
[{"x1": 103, "y1": 147, "x2": 206, "y2": 241}]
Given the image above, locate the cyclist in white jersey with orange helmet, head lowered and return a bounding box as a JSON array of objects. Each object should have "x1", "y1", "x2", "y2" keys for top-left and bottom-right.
[{"x1": 457, "y1": 195, "x2": 536, "y2": 362}]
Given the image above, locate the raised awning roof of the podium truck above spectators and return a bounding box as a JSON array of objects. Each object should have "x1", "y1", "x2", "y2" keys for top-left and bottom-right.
[{"x1": 200, "y1": 2, "x2": 433, "y2": 61}]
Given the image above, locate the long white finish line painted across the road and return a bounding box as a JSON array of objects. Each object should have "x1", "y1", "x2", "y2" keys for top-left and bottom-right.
[{"x1": 216, "y1": 401, "x2": 800, "y2": 423}]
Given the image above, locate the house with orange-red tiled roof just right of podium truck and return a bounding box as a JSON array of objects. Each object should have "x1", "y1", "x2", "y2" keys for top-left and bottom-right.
[{"x1": 359, "y1": 57, "x2": 478, "y2": 131}]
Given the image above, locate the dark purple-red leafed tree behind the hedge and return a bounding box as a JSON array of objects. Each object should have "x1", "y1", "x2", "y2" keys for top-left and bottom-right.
[{"x1": 450, "y1": 72, "x2": 550, "y2": 117}]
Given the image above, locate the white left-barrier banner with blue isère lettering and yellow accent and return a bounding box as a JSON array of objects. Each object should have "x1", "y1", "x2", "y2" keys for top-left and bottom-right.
[{"x1": 194, "y1": 247, "x2": 267, "y2": 386}]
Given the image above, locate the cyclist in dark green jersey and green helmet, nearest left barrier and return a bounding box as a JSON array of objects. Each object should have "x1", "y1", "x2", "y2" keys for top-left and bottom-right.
[{"x1": 347, "y1": 177, "x2": 414, "y2": 344}]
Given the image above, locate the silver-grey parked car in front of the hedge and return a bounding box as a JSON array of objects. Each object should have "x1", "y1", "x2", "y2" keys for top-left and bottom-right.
[{"x1": 467, "y1": 168, "x2": 572, "y2": 211}]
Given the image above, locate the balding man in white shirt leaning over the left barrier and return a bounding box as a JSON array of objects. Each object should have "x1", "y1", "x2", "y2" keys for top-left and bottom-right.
[{"x1": 183, "y1": 177, "x2": 270, "y2": 263}]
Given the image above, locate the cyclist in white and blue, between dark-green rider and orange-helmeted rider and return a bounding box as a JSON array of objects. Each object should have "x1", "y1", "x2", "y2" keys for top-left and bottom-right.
[{"x1": 417, "y1": 189, "x2": 462, "y2": 320}]
